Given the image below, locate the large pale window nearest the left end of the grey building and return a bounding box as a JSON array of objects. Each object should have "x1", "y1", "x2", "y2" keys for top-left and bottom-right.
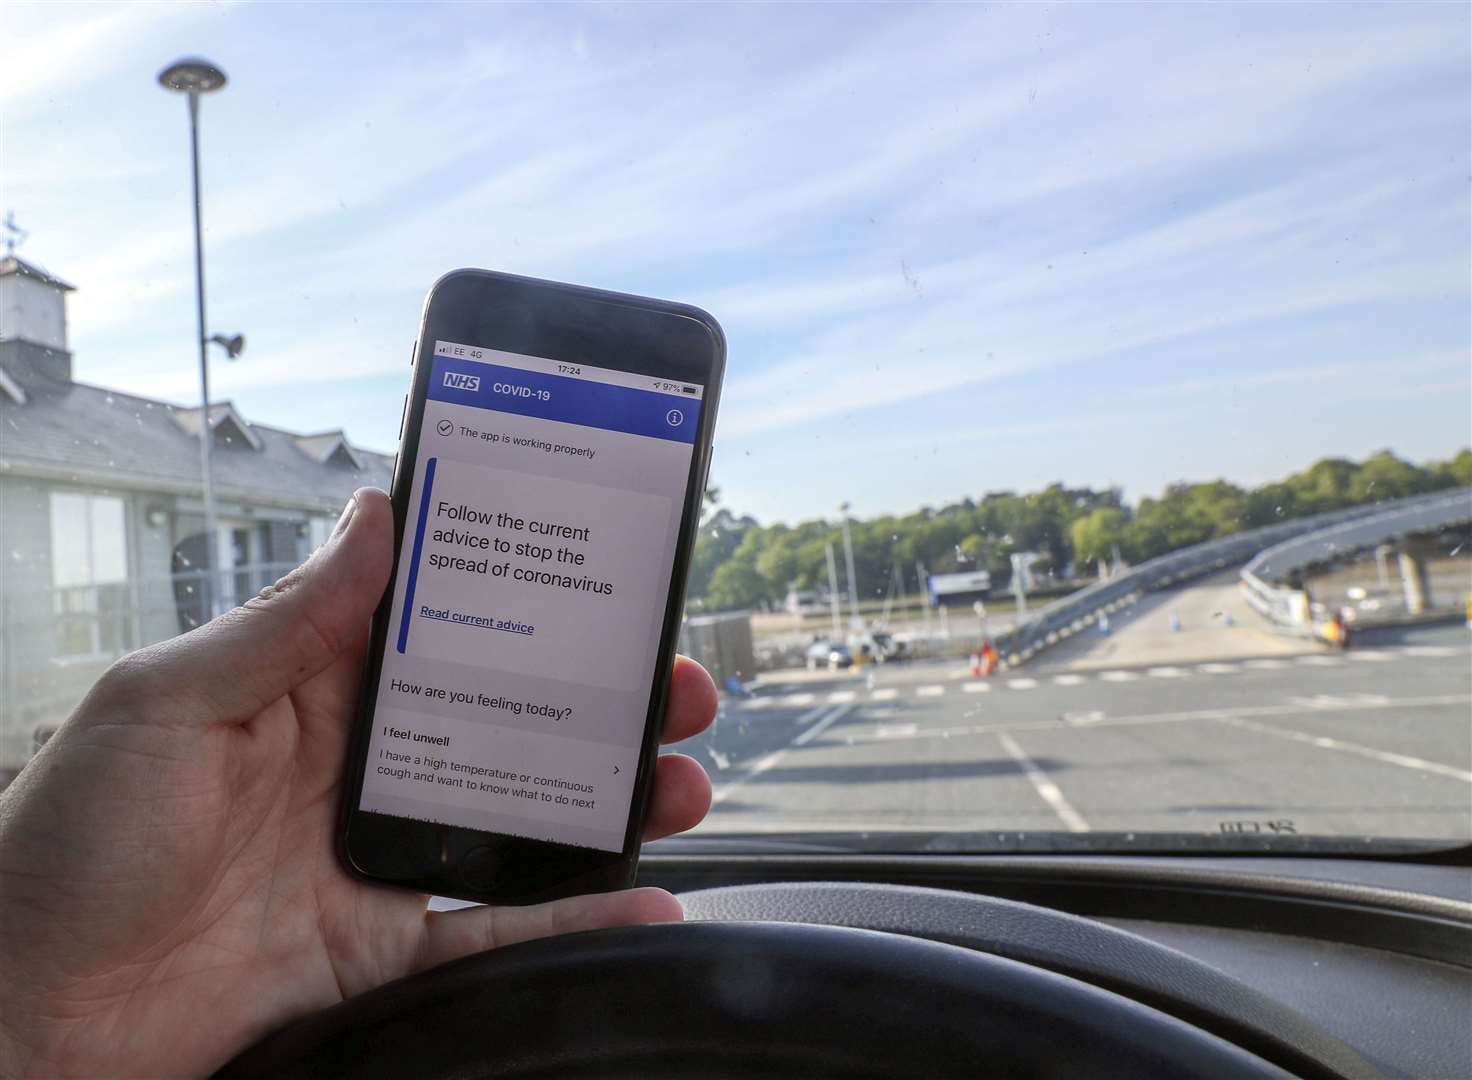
[{"x1": 52, "y1": 491, "x2": 128, "y2": 659}]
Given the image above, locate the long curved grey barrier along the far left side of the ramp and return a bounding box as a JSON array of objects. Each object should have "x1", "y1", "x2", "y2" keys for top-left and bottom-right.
[{"x1": 995, "y1": 490, "x2": 1472, "y2": 667}]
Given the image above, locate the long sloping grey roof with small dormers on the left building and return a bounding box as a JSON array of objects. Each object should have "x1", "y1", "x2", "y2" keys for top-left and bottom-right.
[{"x1": 0, "y1": 368, "x2": 393, "y2": 511}]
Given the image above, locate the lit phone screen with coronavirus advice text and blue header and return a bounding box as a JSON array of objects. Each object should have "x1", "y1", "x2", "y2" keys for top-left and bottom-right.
[{"x1": 359, "y1": 341, "x2": 705, "y2": 852}]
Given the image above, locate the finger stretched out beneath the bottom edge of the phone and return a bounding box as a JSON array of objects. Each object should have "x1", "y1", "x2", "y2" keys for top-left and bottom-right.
[{"x1": 420, "y1": 889, "x2": 684, "y2": 968}]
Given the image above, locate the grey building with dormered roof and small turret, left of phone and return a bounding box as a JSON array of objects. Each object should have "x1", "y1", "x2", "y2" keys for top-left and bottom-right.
[{"x1": 0, "y1": 255, "x2": 393, "y2": 786}]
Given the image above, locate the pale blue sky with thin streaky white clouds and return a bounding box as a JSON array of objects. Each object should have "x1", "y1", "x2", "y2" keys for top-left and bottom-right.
[{"x1": 0, "y1": 3, "x2": 1472, "y2": 521}]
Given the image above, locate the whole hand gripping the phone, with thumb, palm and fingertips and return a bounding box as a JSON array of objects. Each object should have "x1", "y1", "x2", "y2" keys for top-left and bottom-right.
[{"x1": 0, "y1": 489, "x2": 715, "y2": 1076}]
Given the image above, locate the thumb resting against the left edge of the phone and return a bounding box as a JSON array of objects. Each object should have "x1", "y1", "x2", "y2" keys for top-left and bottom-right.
[{"x1": 122, "y1": 487, "x2": 393, "y2": 724}]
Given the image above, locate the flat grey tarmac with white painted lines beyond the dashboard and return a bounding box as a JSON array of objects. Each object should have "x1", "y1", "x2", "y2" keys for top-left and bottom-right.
[{"x1": 680, "y1": 617, "x2": 1472, "y2": 842}]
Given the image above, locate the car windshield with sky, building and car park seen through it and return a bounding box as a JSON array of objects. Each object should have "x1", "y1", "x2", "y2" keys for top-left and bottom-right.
[{"x1": 0, "y1": 3, "x2": 1472, "y2": 852}]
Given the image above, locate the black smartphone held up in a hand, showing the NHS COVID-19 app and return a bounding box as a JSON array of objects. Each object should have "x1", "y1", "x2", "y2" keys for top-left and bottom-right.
[{"x1": 339, "y1": 269, "x2": 726, "y2": 903}]
